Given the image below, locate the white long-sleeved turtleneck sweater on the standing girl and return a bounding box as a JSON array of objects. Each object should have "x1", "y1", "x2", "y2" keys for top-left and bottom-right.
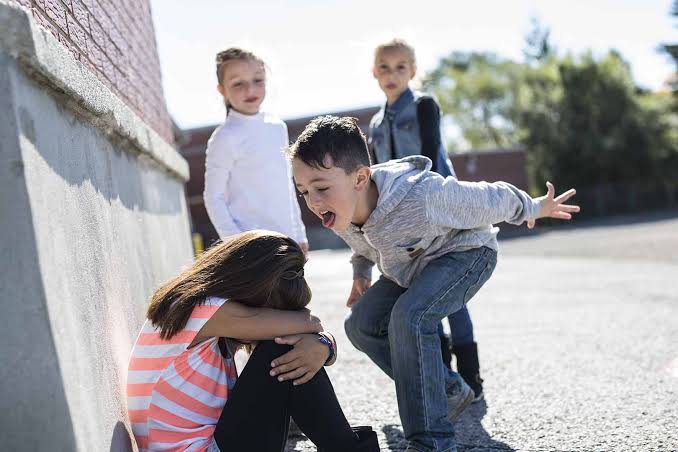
[{"x1": 203, "y1": 110, "x2": 308, "y2": 243}]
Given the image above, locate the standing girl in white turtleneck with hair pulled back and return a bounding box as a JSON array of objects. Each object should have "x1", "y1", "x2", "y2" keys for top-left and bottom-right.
[{"x1": 203, "y1": 48, "x2": 308, "y2": 253}]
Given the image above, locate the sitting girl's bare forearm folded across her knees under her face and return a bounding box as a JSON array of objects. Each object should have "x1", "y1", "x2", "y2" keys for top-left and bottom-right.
[{"x1": 195, "y1": 301, "x2": 323, "y2": 342}]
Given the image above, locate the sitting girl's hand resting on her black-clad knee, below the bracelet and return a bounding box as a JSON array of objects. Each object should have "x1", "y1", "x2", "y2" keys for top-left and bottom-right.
[{"x1": 271, "y1": 334, "x2": 330, "y2": 386}]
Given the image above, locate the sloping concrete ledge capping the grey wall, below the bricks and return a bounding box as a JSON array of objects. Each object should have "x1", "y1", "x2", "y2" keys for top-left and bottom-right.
[{"x1": 0, "y1": 0, "x2": 189, "y2": 181}]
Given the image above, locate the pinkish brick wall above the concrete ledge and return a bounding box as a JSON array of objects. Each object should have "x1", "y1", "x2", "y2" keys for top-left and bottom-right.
[{"x1": 11, "y1": 0, "x2": 173, "y2": 142}]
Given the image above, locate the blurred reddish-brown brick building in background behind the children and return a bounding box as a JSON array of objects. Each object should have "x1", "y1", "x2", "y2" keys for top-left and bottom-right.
[{"x1": 177, "y1": 107, "x2": 527, "y2": 249}]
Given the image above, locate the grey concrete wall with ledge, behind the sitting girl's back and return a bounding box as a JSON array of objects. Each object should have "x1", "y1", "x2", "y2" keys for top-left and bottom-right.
[{"x1": 0, "y1": 1, "x2": 192, "y2": 451}]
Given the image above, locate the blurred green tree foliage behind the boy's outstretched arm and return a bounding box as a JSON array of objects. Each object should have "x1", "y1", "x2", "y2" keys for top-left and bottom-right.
[{"x1": 424, "y1": 19, "x2": 678, "y2": 200}]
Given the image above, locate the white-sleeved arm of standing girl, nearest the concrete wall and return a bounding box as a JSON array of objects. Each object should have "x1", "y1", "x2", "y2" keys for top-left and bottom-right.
[{"x1": 203, "y1": 135, "x2": 242, "y2": 238}]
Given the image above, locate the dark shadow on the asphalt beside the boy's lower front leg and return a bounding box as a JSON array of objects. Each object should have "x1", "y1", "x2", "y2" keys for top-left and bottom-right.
[{"x1": 381, "y1": 400, "x2": 515, "y2": 452}]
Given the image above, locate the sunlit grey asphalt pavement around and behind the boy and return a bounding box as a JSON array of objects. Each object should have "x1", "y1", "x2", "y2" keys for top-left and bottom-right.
[{"x1": 287, "y1": 211, "x2": 678, "y2": 452}]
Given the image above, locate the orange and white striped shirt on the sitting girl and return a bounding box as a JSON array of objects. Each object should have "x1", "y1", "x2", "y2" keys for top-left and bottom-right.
[{"x1": 127, "y1": 297, "x2": 237, "y2": 452}]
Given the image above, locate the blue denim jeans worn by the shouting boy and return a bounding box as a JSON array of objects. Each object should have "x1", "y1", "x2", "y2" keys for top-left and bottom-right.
[{"x1": 344, "y1": 247, "x2": 497, "y2": 451}]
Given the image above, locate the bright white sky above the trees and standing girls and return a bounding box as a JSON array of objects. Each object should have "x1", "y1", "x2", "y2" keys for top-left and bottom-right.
[{"x1": 151, "y1": 0, "x2": 678, "y2": 128}]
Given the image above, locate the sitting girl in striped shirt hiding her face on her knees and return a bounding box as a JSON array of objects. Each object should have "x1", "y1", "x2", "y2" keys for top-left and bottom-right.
[{"x1": 127, "y1": 230, "x2": 379, "y2": 452}]
